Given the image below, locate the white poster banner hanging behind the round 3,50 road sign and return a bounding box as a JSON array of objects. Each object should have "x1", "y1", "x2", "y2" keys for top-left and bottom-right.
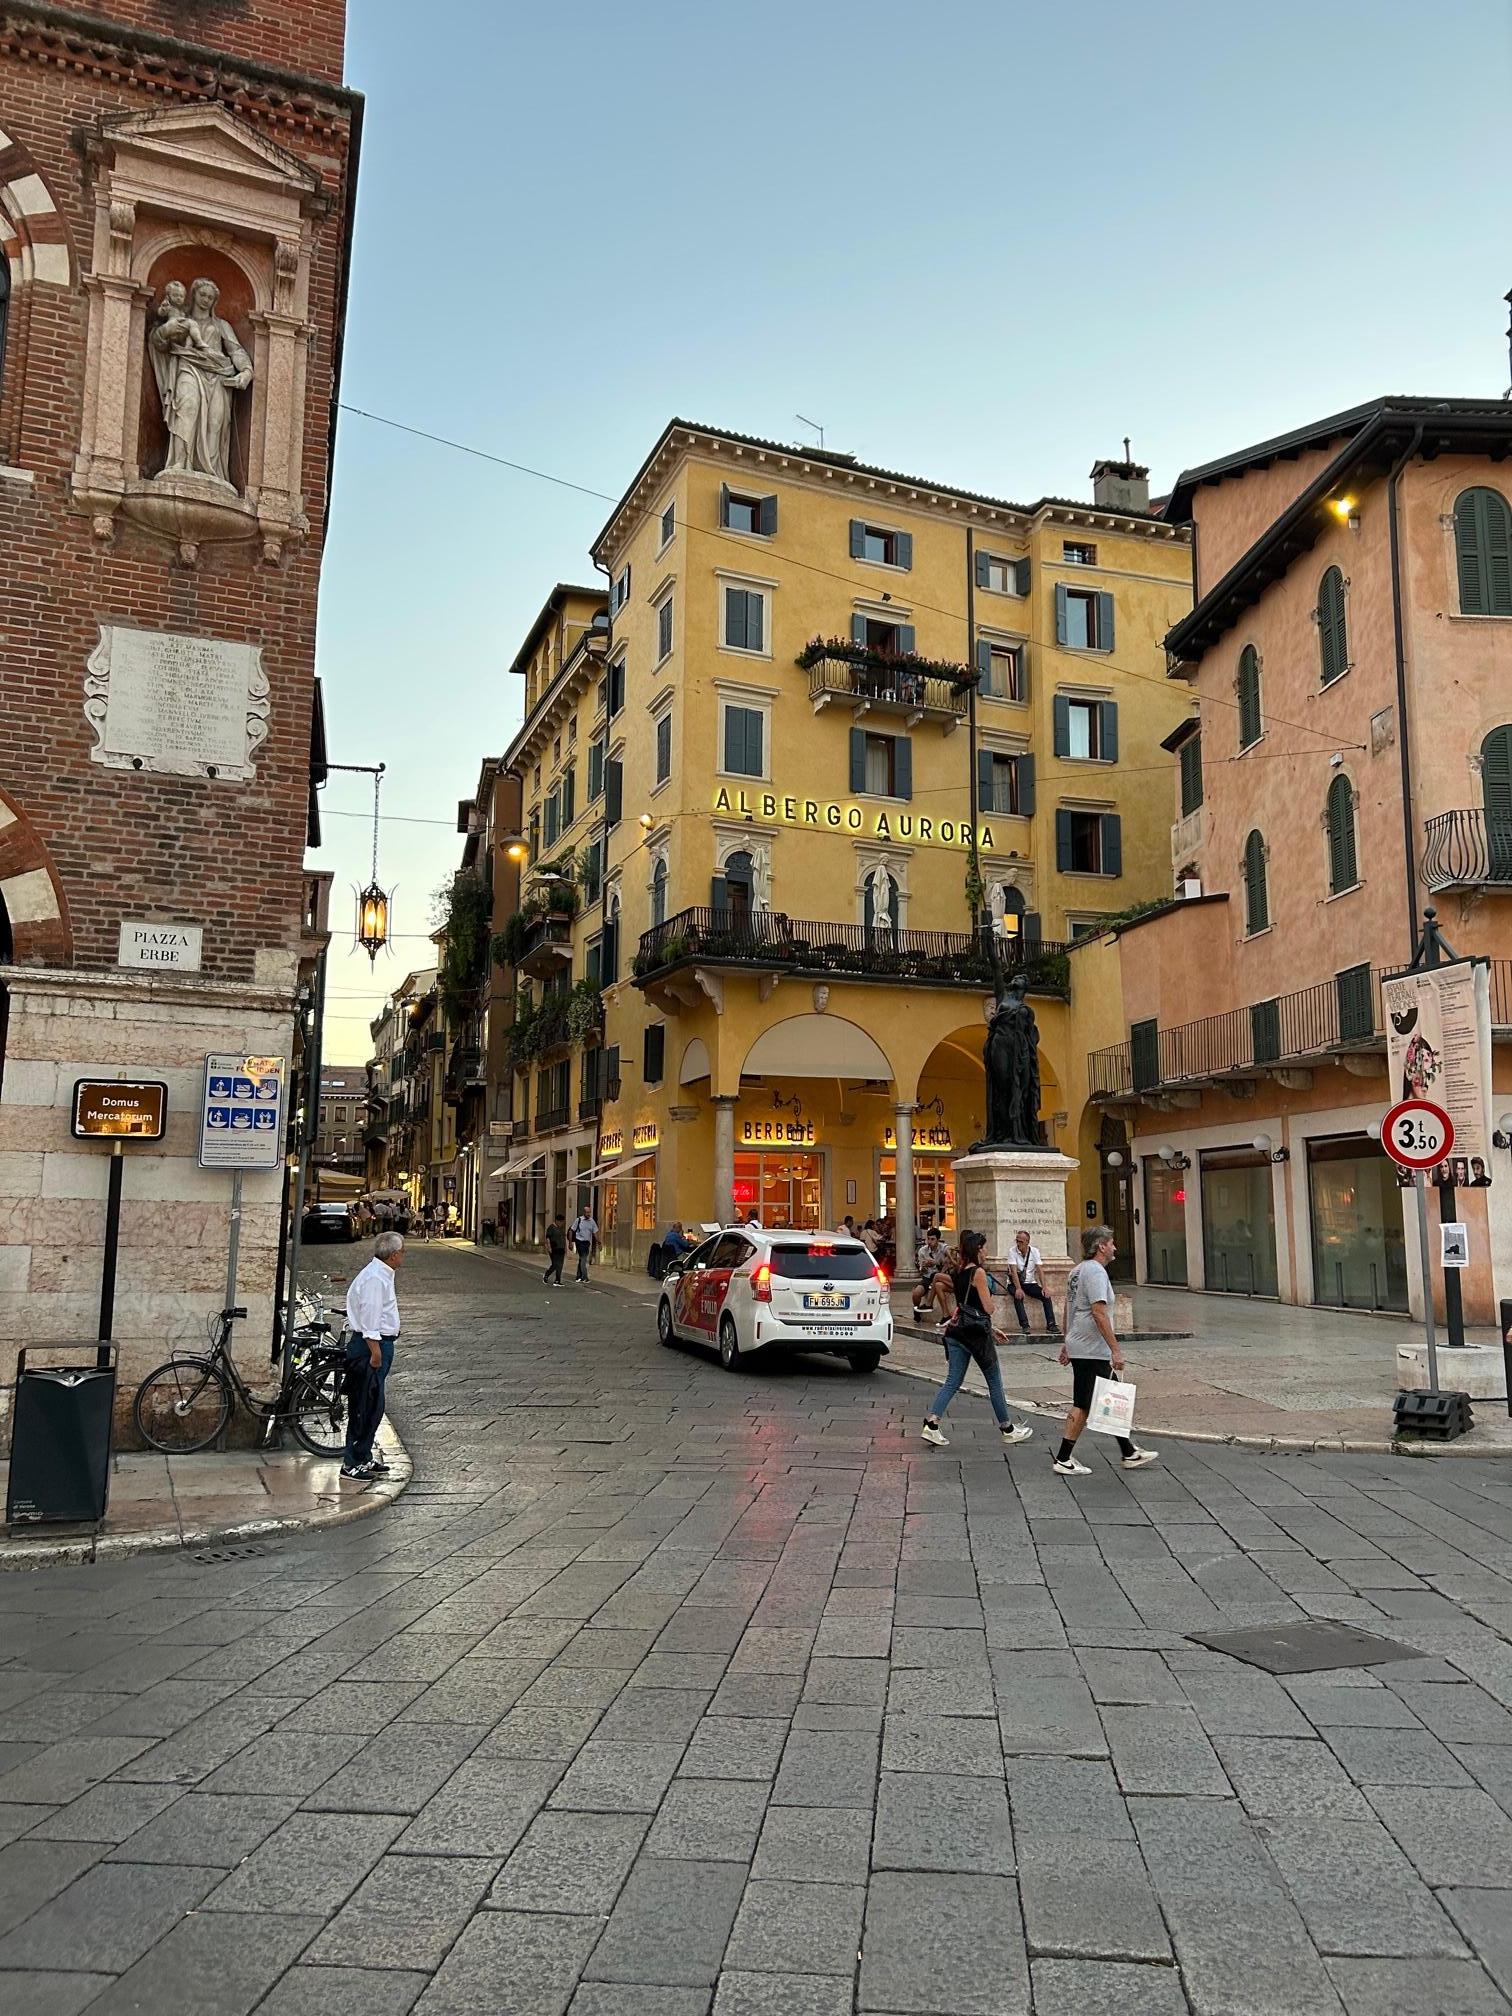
[{"x1": 1381, "y1": 960, "x2": 1492, "y2": 1189}]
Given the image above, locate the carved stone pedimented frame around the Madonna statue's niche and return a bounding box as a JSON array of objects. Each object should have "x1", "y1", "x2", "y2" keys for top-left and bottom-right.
[{"x1": 73, "y1": 105, "x2": 327, "y2": 564}]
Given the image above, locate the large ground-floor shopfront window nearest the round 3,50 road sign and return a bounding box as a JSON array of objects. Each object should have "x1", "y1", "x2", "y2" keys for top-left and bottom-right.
[{"x1": 1306, "y1": 1135, "x2": 1407, "y2": 1314}]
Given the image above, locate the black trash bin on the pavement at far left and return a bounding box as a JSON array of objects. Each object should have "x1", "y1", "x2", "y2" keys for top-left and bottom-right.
[{"x1": 6, "y1": 1345, "x2": 115, "y2": 1526}]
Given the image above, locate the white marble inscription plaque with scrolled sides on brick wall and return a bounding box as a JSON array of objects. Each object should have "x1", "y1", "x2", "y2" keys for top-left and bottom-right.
[{"x1": 85, "y1": 623, "x2": 268, "y2": 782}]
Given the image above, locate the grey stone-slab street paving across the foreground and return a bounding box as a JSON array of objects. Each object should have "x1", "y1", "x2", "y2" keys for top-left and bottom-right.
[{"x1": 0, "y1": 1248, "x2": 1512, "y2": 2016}]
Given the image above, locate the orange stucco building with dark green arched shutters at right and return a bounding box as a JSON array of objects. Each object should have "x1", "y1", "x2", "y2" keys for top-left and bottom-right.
[{"x1": 1073, "y1": 399, "x2": 1512, "y2": 1322}]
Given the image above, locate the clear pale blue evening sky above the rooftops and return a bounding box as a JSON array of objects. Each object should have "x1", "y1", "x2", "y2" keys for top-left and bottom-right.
[{"x1": 312, "y1": 0, "x2": 1512, "y2": 1062}]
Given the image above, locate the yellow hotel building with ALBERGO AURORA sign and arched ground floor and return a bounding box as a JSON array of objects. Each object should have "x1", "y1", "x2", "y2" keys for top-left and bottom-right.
[{"x1": 572, "y1": 421, "x2": 1191, "y2": 1264}]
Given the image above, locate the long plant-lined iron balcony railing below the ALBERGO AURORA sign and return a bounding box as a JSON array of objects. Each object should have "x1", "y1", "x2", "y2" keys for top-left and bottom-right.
[{"x1": 635, "y1": 909, "x2": 1070, "y2": 1000}]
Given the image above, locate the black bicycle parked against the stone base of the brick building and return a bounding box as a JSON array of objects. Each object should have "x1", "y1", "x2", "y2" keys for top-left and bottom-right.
[{"x1": 131, "y1": 1304, "x2": 347, "y2": 1456}]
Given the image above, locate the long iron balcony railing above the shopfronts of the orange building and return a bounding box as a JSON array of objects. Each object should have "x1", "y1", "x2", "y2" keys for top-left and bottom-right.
[{"x1": 1087, "y1": 960, "x2": 1512, "y2": 1099}]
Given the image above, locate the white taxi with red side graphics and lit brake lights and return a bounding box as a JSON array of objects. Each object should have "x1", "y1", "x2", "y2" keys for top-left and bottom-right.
[{"x1": 657, "y1": 1226, "x2": 893, "y2": 1373}]
